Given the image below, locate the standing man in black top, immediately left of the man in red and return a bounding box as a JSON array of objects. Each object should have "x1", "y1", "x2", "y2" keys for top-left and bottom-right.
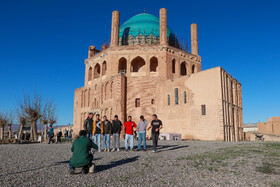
[{"x1": 112, "y1": 115, "x2": 122, "y2": 151}]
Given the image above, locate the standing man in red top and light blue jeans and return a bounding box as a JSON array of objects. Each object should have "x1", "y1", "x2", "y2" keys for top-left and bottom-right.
[{"x1": 124, "y1": 116, "x2": 137, "y2": 151}]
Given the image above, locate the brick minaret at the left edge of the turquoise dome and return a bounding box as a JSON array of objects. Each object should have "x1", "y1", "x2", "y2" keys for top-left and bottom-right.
[{"x1": 110, "y1": 11, "x2": 120, "y2": 47}]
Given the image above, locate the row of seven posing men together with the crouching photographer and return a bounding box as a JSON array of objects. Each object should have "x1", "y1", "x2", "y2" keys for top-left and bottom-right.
[{"x1": 69, "y1": 113, "x2": 162, "y2": 175}]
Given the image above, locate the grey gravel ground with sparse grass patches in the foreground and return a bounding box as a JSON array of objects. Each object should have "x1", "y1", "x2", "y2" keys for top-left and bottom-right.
[{"x1": 0, "y1": 141, "x2": 280, "y2": 186}]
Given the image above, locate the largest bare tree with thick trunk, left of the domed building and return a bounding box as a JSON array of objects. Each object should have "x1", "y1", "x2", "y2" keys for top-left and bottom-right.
[{"x1": 18, "y1": 93, "x2": 42, "y2": 141}]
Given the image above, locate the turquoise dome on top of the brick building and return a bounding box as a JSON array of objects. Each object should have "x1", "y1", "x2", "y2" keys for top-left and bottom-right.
[{"x1": 119, "y1": 13, "x2": 174, "y2": 38}]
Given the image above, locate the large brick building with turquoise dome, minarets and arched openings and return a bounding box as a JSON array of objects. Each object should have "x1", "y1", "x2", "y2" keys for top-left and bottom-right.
[{"x1": 73, "y1": 8, "x2": 243, "y2": 141}]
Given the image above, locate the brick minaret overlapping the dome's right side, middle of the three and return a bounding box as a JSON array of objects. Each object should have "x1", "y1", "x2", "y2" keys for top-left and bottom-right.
[{"x1": 159, "y1": 8, "x2": 167, "y2": 45}]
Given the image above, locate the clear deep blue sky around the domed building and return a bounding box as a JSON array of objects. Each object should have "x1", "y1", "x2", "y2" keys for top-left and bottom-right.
[{"x1": 0, "y1": 0, "x2": 280, "y2": 125}]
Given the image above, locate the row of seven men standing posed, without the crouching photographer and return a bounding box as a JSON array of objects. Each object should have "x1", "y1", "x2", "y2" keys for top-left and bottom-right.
[{"x1": 84, "y1": 113, "x2": 162, "y2": 152}]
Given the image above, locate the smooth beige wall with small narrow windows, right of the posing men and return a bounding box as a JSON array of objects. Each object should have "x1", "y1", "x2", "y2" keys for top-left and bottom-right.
[{"x1": 158, "y1": 67, "x2": 223, "y2": 140}]
